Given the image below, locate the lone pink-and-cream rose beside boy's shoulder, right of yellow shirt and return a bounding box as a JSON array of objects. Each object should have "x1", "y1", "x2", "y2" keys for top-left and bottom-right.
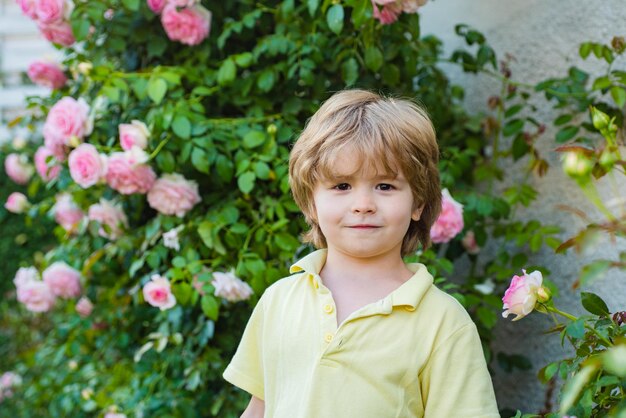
[{"x1": 502, "y1": 270, "x2": 546, "y2": 321}]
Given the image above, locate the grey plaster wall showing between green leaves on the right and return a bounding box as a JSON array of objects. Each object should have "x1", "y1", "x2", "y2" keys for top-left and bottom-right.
[{"x1": 421, "y1": 0, "x2": 626, "y2": 413}]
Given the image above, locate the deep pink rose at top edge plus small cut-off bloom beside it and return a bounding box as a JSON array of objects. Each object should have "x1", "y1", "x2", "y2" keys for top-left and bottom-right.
[{"x1": 147, "y1": 0, "x2": 211, "y2": 45}]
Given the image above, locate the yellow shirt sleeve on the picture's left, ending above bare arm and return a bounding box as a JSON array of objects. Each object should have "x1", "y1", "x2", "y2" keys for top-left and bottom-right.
[{"x1": 223, "y1": 297, "x2": 265, "y2": 400}]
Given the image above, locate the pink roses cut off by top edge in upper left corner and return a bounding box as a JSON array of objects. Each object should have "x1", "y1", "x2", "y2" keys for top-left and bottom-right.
[{"x1": 16, "y1": 0, "x2": 76, "y2": 46}]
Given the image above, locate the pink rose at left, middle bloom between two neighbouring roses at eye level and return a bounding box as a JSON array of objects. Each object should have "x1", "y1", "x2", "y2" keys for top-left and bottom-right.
[{"x1": 106, "y1": 151, "x2": 156, "y2": 194}]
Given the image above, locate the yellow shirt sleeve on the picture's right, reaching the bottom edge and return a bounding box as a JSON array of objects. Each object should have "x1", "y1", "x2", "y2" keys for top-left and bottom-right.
[{"x1": 420, "y1": 323, "x2": 500, "y2": 418}]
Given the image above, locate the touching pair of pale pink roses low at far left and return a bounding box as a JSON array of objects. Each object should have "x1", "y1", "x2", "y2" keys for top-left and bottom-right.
[{"x1": 13, "y1": 261, "x2": 82, "y2": 312}]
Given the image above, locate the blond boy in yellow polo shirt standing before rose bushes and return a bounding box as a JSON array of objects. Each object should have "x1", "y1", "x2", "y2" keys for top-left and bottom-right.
[{"x1": 224, "y1": 90, "x2": 499, "y2": 418}]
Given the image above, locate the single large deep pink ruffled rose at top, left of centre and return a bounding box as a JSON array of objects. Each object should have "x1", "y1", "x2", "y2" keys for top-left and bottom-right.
[{"x1": 161, "y1": 4, "x2": 211, "y2": 45}]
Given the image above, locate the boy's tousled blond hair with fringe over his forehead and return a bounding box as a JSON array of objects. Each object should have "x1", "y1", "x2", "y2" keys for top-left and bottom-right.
[{"x1": 289, "y1": 89, "x2": 441, "y2": 255}]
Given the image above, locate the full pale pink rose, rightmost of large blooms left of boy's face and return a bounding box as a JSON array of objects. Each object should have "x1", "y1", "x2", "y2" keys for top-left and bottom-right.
[{"x1": 148, "y1": 174, "x2": 201, "y2": 218}]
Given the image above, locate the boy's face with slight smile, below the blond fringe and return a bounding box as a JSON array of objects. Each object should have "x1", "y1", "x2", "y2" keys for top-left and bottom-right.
[{"x1": 313, "y1": 152, "x2": 422, "y2": 258}]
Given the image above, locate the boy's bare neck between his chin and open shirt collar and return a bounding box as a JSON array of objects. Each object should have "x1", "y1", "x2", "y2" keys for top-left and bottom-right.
[{"x1": 320, "y1": 248, "x2": 413, "y2": 282}]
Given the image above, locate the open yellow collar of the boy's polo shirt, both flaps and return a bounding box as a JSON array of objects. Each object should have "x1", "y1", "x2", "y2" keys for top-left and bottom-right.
[{"x1": 289, "y1": 249, "x2": 433, "y2": 310}]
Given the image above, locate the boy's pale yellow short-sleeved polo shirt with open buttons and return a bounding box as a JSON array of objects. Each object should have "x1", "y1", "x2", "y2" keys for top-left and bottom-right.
[{"x1": 224, "y1": 250, "x2": 500, "y2": 418}]
